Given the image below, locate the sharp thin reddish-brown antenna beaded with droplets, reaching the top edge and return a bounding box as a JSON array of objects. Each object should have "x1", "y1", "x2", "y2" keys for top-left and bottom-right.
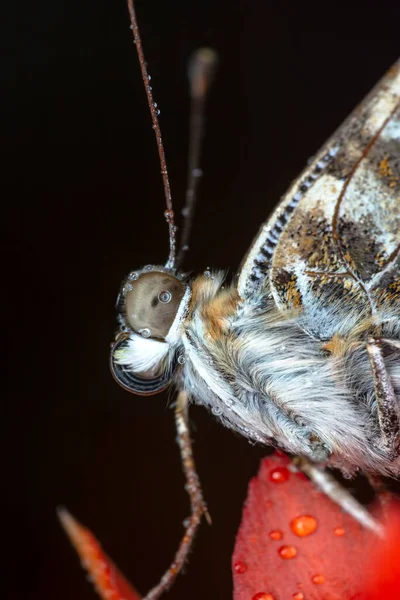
[{"x1": 127, "y1": 0, "x2": 176, "y2": 269}]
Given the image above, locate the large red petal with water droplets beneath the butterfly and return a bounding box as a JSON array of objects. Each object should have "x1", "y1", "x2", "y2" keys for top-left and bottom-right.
[{"x1": 233, "y1": 455, "x2": 394, "y2": 600}]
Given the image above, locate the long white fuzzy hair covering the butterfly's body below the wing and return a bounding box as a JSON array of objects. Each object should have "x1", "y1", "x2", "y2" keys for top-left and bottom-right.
[{"x1": 182, "y1": 276, "x2": 400, "y2": 474}]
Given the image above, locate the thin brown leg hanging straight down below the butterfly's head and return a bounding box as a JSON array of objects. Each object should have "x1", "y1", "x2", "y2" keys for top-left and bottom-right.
[{"x1": 143, "y1": 392, "x2": 211, "y2": 600}]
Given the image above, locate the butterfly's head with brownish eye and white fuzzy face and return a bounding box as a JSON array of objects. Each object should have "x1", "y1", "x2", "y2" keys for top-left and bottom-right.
[{"x1": 110, "y1": 265, "x2": 191, "y2": 396}]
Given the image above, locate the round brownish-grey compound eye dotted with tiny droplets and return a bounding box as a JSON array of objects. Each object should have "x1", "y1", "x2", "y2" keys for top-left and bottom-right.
[{"x1": 125, "y1": 272, "x2": 186, "y2": 339}]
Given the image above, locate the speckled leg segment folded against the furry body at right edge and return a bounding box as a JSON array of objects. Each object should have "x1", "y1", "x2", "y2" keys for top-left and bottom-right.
[{"x1": 367, "y1": 338, "x2": 400, "y2": 460}]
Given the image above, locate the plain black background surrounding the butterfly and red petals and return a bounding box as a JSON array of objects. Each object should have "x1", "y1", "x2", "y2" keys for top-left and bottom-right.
[{"x1": 5, "y1": 0, "x2": 400, "y2": 600}]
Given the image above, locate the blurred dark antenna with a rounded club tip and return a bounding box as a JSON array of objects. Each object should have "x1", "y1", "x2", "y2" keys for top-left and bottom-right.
[{"x1": 177, "y1": 48, "x2": 218, "y2": 268}]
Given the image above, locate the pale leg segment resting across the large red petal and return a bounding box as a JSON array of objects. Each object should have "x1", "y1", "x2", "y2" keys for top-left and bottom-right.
[{"x1": 293, "y1": 456, "x2": 384, "y2": 537}]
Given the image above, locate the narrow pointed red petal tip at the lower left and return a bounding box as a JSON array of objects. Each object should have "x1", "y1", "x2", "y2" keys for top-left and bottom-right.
[{"x1": 58, "y1": 509, "x2": 140, "y2": 600}]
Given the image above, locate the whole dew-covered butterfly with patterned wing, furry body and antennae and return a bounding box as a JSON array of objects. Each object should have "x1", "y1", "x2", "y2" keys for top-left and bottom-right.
[{"x1": 105, "y1": 0, "x2": 400, "y2": 598}]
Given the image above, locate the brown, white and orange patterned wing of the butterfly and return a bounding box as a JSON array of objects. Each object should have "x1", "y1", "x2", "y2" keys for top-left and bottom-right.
[{"x1": 238, "y1": 61, "x2": 400, "y2": 339}]
